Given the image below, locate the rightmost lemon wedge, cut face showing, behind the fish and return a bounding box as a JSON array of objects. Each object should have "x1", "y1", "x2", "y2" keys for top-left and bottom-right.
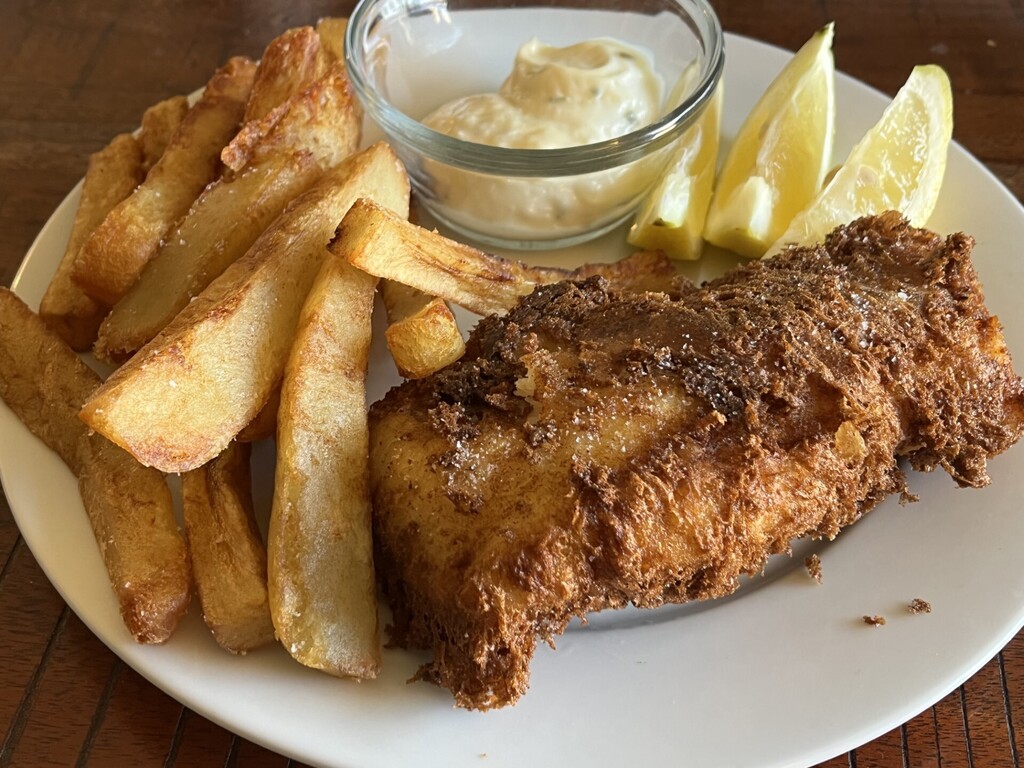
[{"x1": 770, "y1": 65, "x2": 953, "y2": 253}]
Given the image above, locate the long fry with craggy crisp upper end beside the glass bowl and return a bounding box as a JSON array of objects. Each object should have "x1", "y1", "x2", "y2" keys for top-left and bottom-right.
[{"x1": 95, "y1": 65, "x2": 361, "y2": 361}]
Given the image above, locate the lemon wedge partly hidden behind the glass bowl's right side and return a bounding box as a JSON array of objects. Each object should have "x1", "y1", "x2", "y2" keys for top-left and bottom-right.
[{"x1": 626, "y1": 84, "x2": 722, "y2": 260}]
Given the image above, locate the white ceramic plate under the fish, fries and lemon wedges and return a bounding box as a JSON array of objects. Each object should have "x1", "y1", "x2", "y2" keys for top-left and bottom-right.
[{"x1": 0, "y1": 28, "x2": 1024, "y2": 768}]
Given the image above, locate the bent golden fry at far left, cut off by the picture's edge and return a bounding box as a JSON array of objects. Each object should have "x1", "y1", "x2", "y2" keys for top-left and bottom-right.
[{"x1": 0, "y1": 288, "x2": 191, "y2": 643}]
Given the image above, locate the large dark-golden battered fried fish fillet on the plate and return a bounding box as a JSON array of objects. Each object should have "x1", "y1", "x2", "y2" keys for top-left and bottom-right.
[{"x1": 371, "y1": 214, "x2": 1024, "y2": 709}]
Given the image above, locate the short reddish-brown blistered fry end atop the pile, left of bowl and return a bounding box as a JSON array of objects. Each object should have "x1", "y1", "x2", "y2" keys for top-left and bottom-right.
[{"x1": 245, "y1": 27, "x2": 331, "y2": 125}]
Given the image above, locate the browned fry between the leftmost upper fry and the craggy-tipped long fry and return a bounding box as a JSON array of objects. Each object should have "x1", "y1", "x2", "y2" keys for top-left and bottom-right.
[{"x1": 74, "y1": 56, "x2": 255, "y2": 306}]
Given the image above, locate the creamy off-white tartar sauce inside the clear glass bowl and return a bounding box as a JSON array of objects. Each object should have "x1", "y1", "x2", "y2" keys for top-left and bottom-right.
[{"x1": 423, "y1": 38, "x2": 663, "y2": 246}]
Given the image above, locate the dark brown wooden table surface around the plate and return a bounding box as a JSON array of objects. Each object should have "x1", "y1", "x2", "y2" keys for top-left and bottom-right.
[{"x1": 0, "y1": 0, "x2": 1024, "y2": 768}]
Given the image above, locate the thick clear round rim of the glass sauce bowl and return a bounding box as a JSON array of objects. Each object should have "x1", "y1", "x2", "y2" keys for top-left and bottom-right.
[{"x1": 345, "y1": 0, "x2": 725, "y2": 177}]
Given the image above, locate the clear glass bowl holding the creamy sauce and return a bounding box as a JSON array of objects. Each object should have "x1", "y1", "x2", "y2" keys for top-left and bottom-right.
[{"x1": 345, "y1": 0, "x2": 724, "y2": 249}]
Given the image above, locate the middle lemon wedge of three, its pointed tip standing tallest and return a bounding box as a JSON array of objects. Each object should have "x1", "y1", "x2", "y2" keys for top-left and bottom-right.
[{"x1": 705, "y1": 24, "x2": 836, "y2": 258}]
